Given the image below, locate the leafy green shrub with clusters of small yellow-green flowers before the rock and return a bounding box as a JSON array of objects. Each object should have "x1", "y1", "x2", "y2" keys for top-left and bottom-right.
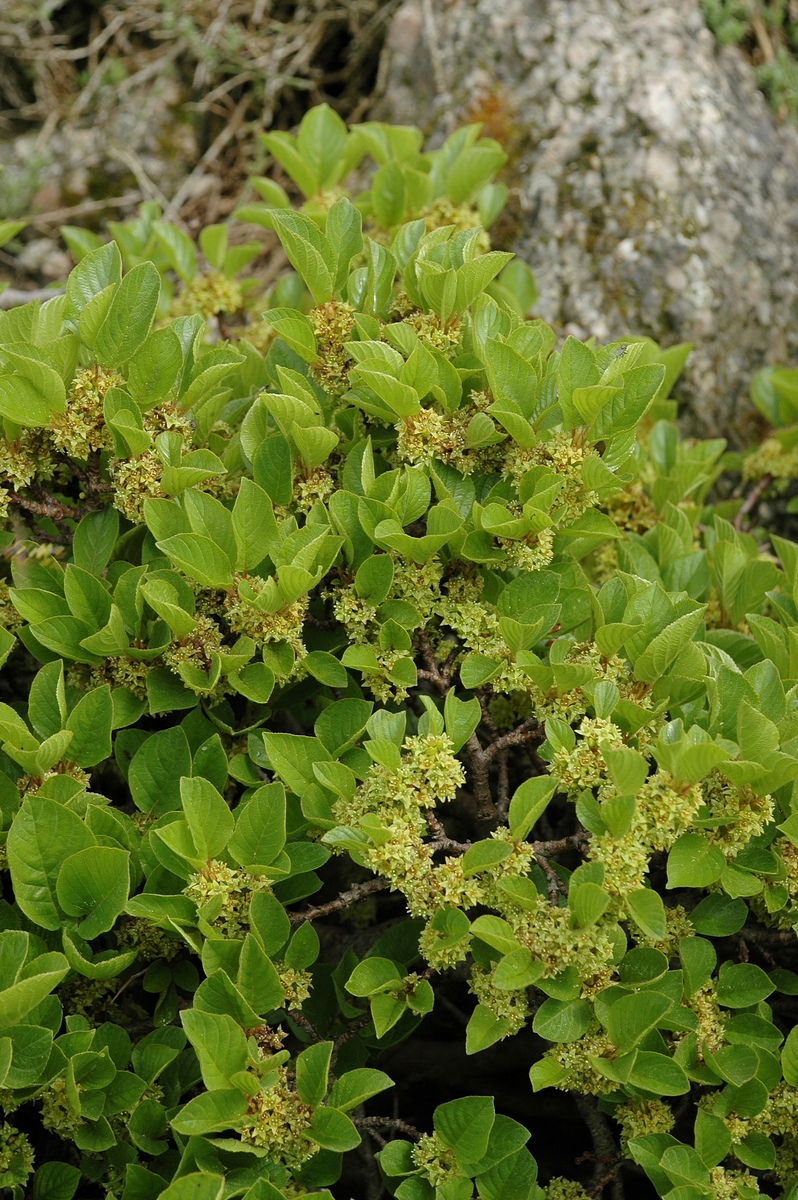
[{"x1": 0, "y1": 108, "x2": 798, "y2": 1200}]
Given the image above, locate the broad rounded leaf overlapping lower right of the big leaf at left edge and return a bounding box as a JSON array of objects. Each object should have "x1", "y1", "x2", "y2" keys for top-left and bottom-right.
[{"x1": 56, "y1": 846, "x2": 130, "y2": 942}]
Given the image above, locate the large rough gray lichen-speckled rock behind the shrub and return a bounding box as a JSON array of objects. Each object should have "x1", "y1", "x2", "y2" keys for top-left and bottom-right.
[{"x1": 378, "y1": 0, "x2": 798, "y2": 440}]
